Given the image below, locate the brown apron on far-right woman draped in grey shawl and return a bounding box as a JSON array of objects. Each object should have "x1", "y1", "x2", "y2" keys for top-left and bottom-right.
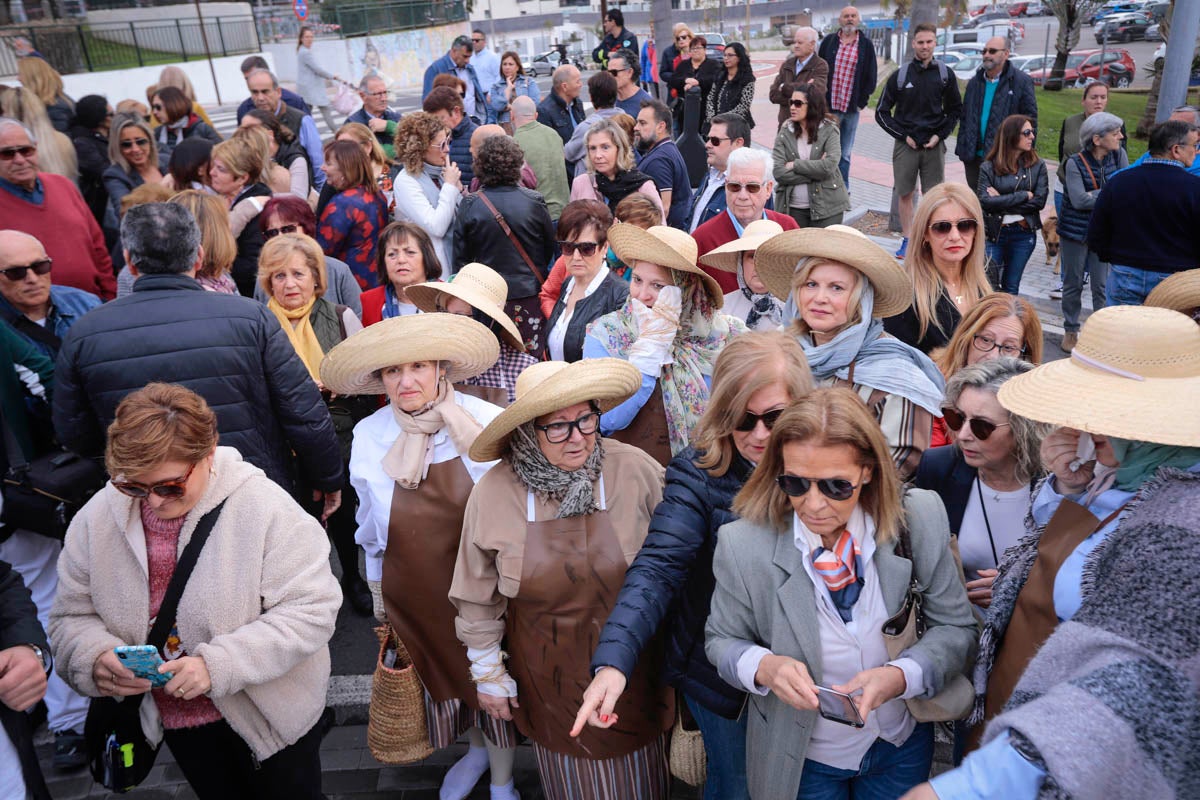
[{"x1": 968, "y1": 498, "x2": 1124, "y2": 750}]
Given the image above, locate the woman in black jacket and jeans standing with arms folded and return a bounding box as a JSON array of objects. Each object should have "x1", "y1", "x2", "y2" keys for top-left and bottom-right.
[{"x1": 977, "y1": 114, "x2": 1050, "y2": 295}]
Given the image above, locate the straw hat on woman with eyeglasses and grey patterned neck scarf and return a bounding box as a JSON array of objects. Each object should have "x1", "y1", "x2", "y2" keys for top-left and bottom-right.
[{"x1": 470, "y1": 359, "x2": 642, "y2": 462}]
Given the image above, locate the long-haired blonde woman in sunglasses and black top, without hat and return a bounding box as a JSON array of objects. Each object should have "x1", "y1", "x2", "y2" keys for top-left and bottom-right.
[{"x1": 883, "y1": 184, "x2": 992, "y2": 354}]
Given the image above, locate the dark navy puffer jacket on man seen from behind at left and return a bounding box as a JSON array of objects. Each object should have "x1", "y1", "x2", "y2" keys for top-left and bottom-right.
[{"x1": 54, "y1": 275, "x2": 342, "y2": 492}]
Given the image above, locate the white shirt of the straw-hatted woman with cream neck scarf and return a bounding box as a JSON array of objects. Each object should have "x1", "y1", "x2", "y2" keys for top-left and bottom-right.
[{"x1": 350, "y1": 392, "x2": 502, "y2": 581}]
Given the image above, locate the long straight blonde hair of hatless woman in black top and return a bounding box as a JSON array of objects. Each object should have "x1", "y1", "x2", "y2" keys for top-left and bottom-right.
[{"x1": 904, "y1": 182, "x2": 991, "y2": 338}]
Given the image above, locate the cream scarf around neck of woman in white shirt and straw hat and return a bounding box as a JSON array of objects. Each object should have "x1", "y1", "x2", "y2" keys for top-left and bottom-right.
[{"x1": 380, "y1": 378, "x2": 484, "y2": 489}]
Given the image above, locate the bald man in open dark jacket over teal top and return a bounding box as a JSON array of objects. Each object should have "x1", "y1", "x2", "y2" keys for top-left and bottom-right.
[{"x1": 954, "y1": 36, "x2": 1038, "y2": 190}]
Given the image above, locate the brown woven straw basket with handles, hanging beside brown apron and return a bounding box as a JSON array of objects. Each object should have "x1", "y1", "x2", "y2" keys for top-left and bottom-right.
[{"x1": 367, "y1": 625, "x2": 433, "y2": 764}]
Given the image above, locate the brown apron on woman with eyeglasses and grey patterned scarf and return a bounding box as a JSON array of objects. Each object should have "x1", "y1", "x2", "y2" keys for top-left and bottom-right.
[{"x1": 506, "y1": 477, "x2": 674, "y2": 760}]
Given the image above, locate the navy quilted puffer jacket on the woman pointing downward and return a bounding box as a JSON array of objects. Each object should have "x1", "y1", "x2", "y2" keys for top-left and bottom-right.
[{"x1": 592, "y1": 447, "x2": 752, "y2": 720}]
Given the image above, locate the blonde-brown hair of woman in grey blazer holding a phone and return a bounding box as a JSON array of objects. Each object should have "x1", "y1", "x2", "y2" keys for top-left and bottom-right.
[{"x1": 733, "y1": 387, "x2": 904, "y2": 543}]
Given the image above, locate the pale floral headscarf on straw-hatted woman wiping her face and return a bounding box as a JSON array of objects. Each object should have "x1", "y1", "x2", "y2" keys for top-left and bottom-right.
[{"x1": 588, "y1": 270, "x2": 746, "y2": 456}]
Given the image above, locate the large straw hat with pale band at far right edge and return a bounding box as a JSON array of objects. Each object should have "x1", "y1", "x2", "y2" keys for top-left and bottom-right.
[{"x1": 1000, "y1": 306, "x2": 1200, "y2": 447}]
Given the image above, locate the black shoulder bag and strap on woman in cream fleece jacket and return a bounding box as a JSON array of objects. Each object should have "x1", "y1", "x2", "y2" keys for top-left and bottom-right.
[{"x1": 83, "y1": 500, "x2": 224, "y2": 794}]
